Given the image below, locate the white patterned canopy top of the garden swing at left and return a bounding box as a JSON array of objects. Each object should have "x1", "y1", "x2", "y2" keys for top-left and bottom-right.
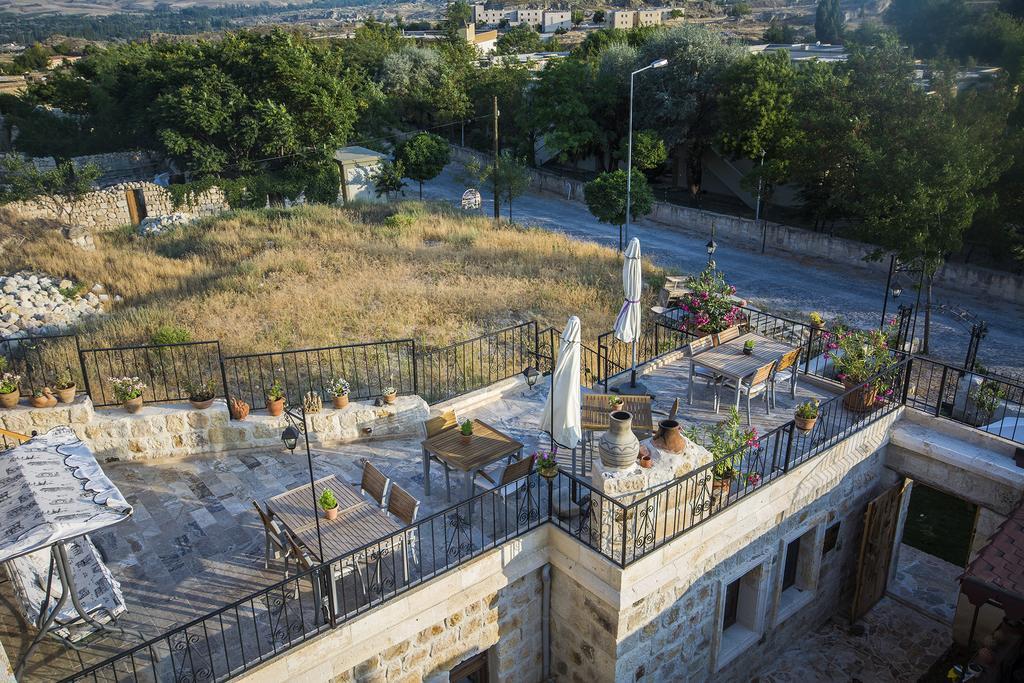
[{"x1": 0, "y1": 427, "x2": 132, "y2": 562}]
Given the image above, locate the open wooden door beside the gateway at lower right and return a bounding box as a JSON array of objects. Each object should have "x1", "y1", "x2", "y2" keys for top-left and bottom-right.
[{"x1": 851, "y1": 479, "x2": 910, "y2": 622}]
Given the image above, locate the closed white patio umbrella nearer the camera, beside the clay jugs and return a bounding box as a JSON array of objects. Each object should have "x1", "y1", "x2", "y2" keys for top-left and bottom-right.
[{"x1": 541, "y1": 315, "x2": 583, "y2": 449}]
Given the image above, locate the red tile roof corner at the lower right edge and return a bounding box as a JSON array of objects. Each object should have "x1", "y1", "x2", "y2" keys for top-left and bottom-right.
[{"x1": 961, "y1": 503, "x2": 1024, "y2": 618}]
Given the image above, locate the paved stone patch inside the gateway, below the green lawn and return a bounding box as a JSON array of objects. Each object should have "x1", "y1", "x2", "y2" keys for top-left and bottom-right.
[{"x1": 889, "y1": 543, "x2": 964, "y2": 624}]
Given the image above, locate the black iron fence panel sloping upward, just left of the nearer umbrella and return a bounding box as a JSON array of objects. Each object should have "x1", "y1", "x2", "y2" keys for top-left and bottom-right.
[{"x1": 418, "y1": 321, "x2": 544, "y2": 403}]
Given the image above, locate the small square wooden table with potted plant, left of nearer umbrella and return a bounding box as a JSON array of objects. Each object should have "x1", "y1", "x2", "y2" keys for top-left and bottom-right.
[{"x1": 421, "y1": 420, "x2": 523, "y2": 503}]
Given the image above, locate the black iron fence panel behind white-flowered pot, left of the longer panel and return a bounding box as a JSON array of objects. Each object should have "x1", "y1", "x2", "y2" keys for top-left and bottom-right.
[{"x1": 79, "y1": 341, "x2": 225, "y2": 408}]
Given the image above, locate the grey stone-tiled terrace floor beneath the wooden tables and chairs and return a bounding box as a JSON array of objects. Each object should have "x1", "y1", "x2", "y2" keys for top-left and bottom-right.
[{"x1": 0, "y1": 342, "x2": 855, "y2": 681}]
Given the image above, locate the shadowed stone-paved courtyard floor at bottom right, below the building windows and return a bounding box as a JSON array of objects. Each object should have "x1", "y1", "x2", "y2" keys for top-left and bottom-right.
[{"x1": 751, "y1": 597, "x2": 952, "y2": 683}]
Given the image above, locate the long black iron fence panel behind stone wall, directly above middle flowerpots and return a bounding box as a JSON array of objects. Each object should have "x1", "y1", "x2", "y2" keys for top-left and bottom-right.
[{"x1": 223, "y1": 339, "x2": 417, "y2": 410}]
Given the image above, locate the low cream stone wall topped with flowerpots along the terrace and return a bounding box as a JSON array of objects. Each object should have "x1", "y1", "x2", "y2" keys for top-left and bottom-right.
[{"x1": 0, "y1": 395, "x2": 429, "y2": 462}]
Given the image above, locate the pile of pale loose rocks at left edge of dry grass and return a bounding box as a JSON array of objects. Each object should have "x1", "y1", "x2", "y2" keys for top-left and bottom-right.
[{"x1": 0, "y1": 272, "x2": 114, "y2": 338}]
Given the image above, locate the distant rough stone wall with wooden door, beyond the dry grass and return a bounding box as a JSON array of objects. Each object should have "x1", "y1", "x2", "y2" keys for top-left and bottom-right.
[{"x1": 0, "y1": 181, "x2": 228, "y2": 230}]
